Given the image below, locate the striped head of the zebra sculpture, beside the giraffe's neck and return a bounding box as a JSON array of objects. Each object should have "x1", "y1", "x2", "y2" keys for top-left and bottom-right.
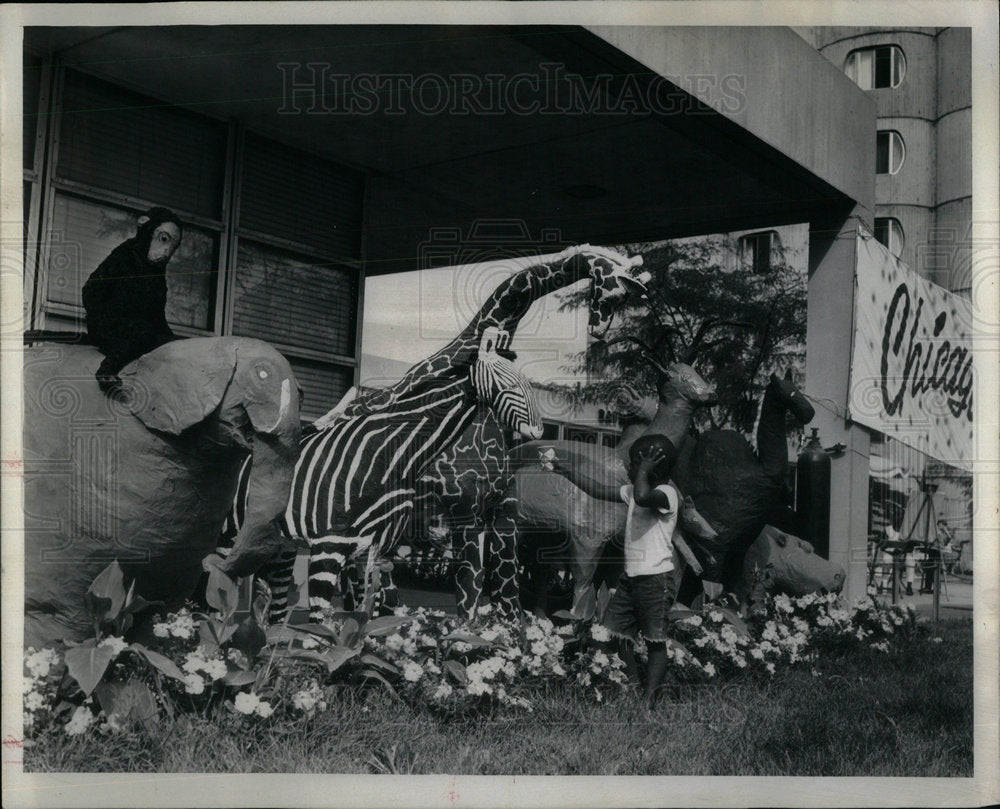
[{"x1": 469, "y1": 326, "x2": 542, "y2": 439}]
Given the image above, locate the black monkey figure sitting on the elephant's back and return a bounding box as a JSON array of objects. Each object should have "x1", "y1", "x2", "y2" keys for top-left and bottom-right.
[{"x1": 83, "y1": 208, "x2": 181, "y2": 393}]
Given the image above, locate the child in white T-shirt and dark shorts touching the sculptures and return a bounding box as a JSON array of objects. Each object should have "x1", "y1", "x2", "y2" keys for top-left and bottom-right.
[{"x1": 552, "y1": 434, "x2": 679, "y2": 708}]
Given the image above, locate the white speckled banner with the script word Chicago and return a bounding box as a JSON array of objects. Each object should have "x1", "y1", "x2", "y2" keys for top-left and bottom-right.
[{"x1": 848, "y1": 224, "x2": 975, "y2": 469}]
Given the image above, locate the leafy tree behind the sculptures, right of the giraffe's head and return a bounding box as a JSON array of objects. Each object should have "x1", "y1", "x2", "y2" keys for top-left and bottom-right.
[{"x1": 550, "y1": 236, "x2": 806, "y2": 433}]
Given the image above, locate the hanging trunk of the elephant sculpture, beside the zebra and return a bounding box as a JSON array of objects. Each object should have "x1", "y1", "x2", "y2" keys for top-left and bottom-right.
[{"x1": 219, "y1": 428, "x2": 299, "y2": 579}]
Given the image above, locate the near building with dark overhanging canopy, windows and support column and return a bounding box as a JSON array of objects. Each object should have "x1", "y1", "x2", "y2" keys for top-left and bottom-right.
[{"x1": 17, "y1": 25, "x2": 876, "y2": 593}]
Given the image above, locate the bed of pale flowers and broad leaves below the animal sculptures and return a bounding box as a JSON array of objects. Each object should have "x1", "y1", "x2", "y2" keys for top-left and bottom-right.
[{"x1": 24, "y1": 566, "x2": 917, "y2": 739}]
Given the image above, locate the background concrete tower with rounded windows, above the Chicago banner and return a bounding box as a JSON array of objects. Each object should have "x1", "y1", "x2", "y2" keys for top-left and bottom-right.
[{"x1": 799, "y1": 27, "x2": 972, "y2": 294}]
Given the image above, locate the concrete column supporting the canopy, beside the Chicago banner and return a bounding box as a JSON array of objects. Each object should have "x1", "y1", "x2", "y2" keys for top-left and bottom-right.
[{"x1": 805, "y1": 206, "x2": 871, "y2": 600}]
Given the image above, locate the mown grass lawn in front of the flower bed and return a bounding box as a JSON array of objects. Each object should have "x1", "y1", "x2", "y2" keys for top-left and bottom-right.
[{"x1": 24, "y1": 620, "x2": 973, "y2": 776}]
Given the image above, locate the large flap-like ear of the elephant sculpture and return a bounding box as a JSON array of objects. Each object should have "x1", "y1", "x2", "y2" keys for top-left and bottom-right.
[{"x1": 119, "y1": 339, "x2": 236, "y2": 435}]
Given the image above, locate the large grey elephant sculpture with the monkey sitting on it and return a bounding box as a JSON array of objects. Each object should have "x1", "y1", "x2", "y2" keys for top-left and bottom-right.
[{"x1": 23, "y1": 337, "x2": 300, "y2": 648}]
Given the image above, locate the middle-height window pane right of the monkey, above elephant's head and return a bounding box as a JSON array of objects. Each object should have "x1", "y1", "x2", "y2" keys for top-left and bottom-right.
[{"x1": 233, "y1": 239, "x2": 358, "y2": 357}]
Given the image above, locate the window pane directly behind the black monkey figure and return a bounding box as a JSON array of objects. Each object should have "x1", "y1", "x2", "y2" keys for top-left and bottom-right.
[{"x1": 46, "y1": 194, "x2": 218, "y2": 330}]
